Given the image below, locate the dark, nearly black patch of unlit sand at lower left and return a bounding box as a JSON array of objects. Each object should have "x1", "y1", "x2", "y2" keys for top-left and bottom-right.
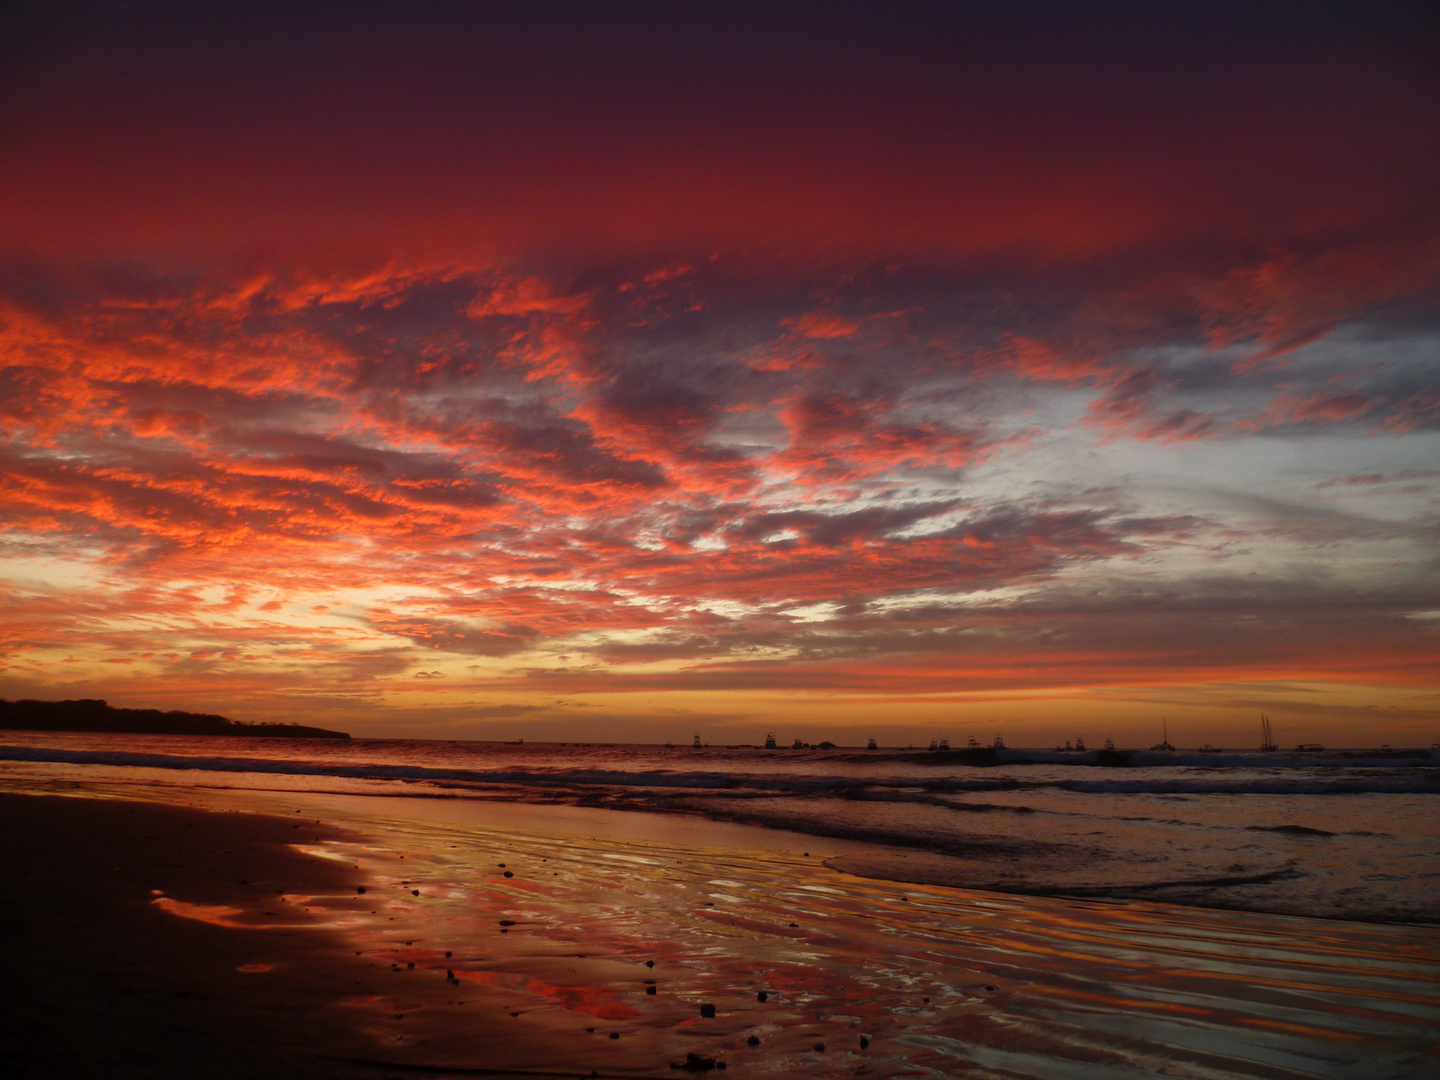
[{"x1": 0, "y1": 795, "x2": 555, "y2": 1079}]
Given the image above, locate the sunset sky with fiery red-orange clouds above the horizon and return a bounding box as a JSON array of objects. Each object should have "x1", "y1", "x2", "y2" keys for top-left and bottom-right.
[{"x1": 0, "y1": 3, "x2": 1440, "y2": 746}]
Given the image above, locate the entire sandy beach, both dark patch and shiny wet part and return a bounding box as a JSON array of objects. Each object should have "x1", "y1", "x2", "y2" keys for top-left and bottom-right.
[{"x1": 0, "y1": 785, "x2": 1440, "y2": 1079}]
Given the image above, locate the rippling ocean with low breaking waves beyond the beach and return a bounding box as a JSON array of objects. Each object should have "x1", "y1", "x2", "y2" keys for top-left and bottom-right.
[{"x1": 0, "y1": 732, "x2": 1440, "y2": 923}]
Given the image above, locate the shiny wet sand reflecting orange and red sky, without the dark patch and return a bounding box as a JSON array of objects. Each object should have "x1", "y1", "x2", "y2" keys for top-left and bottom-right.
[{"x1": 25, "y1": 793, "x2": 1440, "y2": 1077}]
